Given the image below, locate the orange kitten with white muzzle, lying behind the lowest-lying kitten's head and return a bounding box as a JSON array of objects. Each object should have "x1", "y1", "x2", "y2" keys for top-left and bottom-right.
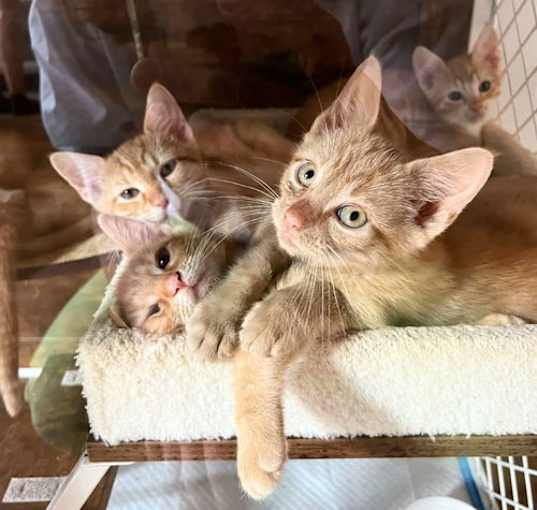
[{"x1": 50, "y1": 84, "x2": 292, "y2": 241}]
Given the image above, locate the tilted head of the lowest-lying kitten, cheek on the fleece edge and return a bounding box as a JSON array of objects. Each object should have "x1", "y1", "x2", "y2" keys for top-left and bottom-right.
[{"x1": 99, "y1": 216, "x2": 232, "y2": 334}]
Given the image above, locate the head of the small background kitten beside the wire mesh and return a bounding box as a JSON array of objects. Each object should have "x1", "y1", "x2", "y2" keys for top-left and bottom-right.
[{"x1": 412, "y1": 25, "x2": 501, "y2": 134}]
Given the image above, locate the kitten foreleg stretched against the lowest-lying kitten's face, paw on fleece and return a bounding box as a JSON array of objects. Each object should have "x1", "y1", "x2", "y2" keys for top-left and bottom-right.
[{"x1": 186, "y1": 224, "x2": 290, "y2": 360}]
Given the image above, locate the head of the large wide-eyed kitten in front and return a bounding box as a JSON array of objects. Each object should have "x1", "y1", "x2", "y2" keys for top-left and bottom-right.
[{"x1": 273, "y1": 58, "x2": 492, "y2": 268}]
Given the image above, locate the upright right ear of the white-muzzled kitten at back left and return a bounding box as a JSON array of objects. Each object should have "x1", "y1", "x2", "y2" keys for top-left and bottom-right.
[{"x1": 144, "y1": 83, "x2": 194, "y2": 142}]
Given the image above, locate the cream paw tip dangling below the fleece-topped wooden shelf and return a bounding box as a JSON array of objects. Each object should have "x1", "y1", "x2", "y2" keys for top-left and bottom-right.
[{"x1": 237, "y1": 422, "x2": 287, "y2": 500}]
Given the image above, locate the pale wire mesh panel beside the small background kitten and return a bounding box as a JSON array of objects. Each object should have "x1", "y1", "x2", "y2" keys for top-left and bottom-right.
[{"x1": 492, "y1": 0, "x2": 537, "y2": 153}]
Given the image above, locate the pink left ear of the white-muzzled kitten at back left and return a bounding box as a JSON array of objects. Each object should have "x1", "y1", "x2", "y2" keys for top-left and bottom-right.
[{"x1": 49, "y1": 152, "x2": 105, "y2": 206}]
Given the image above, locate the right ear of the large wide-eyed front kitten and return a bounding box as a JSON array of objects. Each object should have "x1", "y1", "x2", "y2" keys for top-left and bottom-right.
[{"x1": 410, "y1": 148, "x2": 494, "y2": 248}]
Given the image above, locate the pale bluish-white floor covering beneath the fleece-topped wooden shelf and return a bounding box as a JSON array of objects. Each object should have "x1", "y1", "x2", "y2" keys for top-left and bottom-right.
[{"x1": 108, "y1": 459, "x2": 474, "y2": 510}]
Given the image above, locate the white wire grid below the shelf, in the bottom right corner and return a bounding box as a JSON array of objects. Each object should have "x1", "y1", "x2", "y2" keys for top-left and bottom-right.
[{"x1": 474, "y1": 457, "x2": 537, "y2": 510}]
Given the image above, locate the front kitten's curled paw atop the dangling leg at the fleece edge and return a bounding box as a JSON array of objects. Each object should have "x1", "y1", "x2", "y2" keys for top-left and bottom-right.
[{"x1": 239, "y1": 299, "x2": 301, "y2": 358}]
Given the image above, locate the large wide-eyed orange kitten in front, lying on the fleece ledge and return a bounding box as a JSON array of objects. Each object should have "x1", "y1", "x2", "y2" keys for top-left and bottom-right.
[{"x1": 187, "y1": 58, "x2": 537, "y2": 498}]
